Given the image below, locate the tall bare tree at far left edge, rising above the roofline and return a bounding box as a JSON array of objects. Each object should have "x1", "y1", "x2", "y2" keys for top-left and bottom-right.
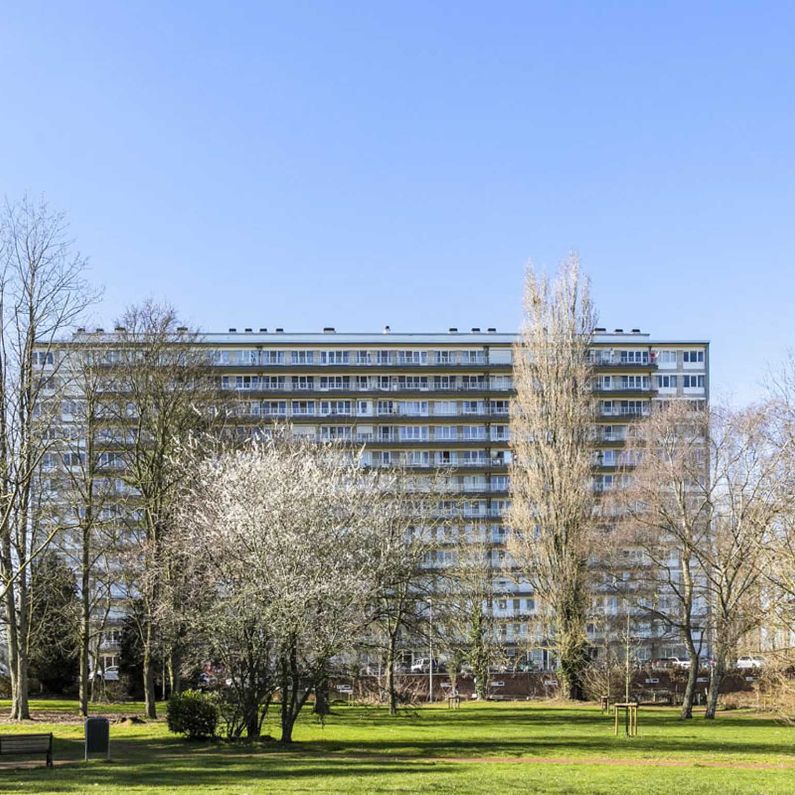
[{"x1": 0, "y1": 198, "x2": 95, "y2": 719}]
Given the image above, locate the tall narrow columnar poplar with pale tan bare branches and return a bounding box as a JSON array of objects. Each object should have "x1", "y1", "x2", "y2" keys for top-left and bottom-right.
[{"x1": 507, "y1": 256, "x2": 596, "y2": 699}]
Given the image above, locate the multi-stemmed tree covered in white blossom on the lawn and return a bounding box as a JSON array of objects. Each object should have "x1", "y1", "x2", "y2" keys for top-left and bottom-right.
[{"x1": 175, "y1": 428, "x2": 386, "y2": 743}]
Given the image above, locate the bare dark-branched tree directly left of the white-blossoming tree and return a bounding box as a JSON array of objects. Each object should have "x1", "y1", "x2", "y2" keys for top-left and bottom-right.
[{"x1": 105, "y1": 301, "x2": 219, "y2": 718}]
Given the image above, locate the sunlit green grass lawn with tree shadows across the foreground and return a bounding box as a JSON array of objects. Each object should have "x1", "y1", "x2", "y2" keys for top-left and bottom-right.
[{"x1": 0, "y1": 701, "x2": 795, "y2": 795}]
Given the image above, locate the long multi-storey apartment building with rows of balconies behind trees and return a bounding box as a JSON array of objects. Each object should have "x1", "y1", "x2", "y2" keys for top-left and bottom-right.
[{"x1": 38, "y1": 326, "x2": 709, "y2": 667}]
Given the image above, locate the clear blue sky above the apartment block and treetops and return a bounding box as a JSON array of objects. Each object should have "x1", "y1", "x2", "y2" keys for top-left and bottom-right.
[{"x1": 0, "y1": 0, "x2": 795, "y2": 399}]
